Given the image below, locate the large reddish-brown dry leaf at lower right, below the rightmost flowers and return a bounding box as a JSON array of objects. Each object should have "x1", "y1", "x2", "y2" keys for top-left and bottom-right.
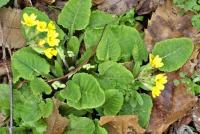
[{"x1": 147, "y1": 72, "x2": 197, "y2": 134}]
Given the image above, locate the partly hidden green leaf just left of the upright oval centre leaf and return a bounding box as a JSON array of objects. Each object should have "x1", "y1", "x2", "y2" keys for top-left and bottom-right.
[{"x1": 84, "y1": 28, "x2": 103, "y2": 49}]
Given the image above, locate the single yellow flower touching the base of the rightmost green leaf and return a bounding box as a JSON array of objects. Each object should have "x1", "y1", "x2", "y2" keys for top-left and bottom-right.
[{"x1": 149, "y1": 54, "x2": 164, "y2": 68}]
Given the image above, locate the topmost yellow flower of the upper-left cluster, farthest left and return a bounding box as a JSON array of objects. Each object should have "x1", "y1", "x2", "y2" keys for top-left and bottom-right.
[{"x1": 21, "y1": 13, "x2": 37, "y2": 27}]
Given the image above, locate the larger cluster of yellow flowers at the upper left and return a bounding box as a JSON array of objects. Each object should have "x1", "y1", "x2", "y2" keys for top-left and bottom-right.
[{"x1": 21, "y1": 13, "x2": 60, "y2": 59}]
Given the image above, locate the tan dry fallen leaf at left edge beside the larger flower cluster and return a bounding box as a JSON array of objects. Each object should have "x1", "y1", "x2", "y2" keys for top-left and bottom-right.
[{"x1": 0, "y1": 8, "x2": 25, "y2": 49}]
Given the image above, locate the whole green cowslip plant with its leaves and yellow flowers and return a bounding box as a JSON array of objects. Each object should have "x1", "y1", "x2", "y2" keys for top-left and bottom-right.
[{"x1": 0, "y1": 0, "x2": 193, "y2": 134}]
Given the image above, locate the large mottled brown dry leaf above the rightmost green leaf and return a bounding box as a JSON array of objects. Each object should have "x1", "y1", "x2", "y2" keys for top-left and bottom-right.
[{"x1": 145, "y1": 0, "x2": 200, "y2": 51}]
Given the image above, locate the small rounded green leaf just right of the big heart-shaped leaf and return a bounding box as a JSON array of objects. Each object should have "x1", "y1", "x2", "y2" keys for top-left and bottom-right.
[{"x1": 103, "y1": 89, "x2": 124, "y2": 115}]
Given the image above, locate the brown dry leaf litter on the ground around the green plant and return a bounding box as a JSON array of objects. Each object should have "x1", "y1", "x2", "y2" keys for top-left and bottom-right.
[{"x1": 0, "y1": 0, "x2": 200, "y2": 134}]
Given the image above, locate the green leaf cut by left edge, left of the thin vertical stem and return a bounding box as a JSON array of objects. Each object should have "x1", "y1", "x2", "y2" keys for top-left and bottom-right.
[{"x1": 0, "y1": 84, "x2": 10, "y2": 114}]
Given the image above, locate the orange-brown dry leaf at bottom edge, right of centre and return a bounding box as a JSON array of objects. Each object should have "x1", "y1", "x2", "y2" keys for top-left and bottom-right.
[{"x1": 99, "y1": 115, "x2": 145, "y2": 134}]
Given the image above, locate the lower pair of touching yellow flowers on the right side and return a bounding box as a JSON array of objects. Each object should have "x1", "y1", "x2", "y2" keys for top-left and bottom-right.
[{"x1": 152, "y1": 74, "x2": 167, "y2": 98}]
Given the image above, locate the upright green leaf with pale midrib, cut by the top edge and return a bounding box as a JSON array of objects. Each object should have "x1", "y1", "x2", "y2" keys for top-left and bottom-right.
[{"x1": 58, "y1": 0, "x2": 92, "y2": 31}]
